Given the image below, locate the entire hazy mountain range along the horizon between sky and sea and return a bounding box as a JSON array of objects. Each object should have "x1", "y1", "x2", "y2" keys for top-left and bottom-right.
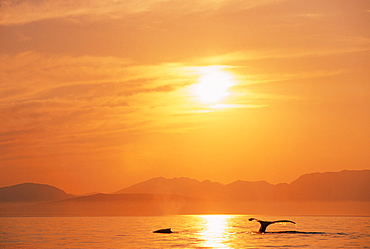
[{"x1": 0, "y1": 170, "x2": 370, "y2": 216}]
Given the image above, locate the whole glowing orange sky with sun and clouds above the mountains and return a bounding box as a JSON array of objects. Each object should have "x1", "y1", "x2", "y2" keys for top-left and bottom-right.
[{"x1": 0, "y1": 0, "x2": 370, "y2": 193}]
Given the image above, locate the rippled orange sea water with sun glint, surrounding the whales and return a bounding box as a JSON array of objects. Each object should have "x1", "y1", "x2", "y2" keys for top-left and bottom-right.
[{"x1": 0, "y1": 215, "x2": 370, "y2": 249}]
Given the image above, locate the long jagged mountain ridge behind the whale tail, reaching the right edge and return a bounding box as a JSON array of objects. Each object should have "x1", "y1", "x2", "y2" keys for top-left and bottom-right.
[{"x1": 116, "y1": 170, "x2": 370, "y2": 201}]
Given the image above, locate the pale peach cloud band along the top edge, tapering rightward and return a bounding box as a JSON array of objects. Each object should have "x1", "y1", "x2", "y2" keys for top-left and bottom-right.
[{"x1": 0, "y1": 0, "x2": 280, "y2": 25}]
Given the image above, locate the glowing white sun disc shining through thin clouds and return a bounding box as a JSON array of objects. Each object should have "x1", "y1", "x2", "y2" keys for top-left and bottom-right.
[{"x1": 192, "y1": 66, "x2": 234, "y2": 105}]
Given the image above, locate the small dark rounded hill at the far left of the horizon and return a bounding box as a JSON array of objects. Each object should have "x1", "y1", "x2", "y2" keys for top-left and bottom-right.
[{"x1": 0, "y1": 183, "x2": 74, "y2": 203}]
